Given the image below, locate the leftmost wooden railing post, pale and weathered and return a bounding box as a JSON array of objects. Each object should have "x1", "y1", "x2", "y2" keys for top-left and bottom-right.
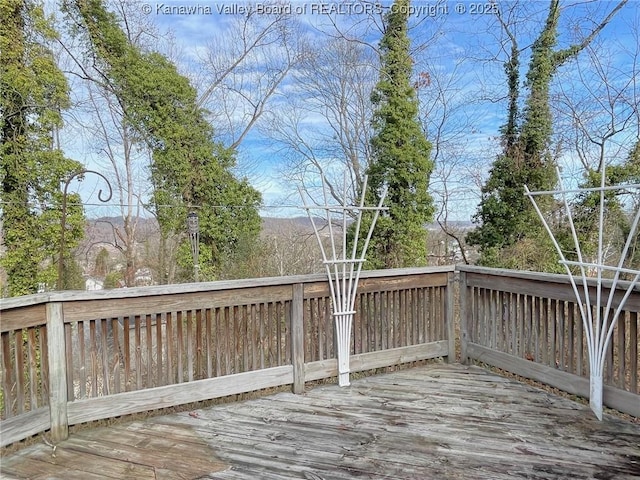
[{"x1": 46, "y1": 302, "x2": 69, "y2": 442}]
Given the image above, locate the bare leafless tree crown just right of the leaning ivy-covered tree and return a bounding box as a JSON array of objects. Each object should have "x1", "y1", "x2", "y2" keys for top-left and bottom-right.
[{"x1": 197, "y1": 9, "x2": 309, "y2": 149}]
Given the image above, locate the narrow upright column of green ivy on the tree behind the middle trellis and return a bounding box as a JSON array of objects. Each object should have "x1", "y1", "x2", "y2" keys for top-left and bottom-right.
[{"x1": 363, "y1": 0, "x2": 434, "y2": 268}]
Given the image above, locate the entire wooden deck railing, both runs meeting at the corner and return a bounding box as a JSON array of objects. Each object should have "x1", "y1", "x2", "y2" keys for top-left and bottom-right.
[{"x1": 0, "y1": 267, "x2": 640, "y2": 446}]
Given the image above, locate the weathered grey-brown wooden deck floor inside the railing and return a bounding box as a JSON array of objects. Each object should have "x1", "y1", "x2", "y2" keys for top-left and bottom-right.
[{"x1": 0, "y1": 364, "x2": 640, "y2": 480}]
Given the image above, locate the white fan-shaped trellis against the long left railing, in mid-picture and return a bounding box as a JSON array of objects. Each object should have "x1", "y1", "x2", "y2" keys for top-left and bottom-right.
[{"x1": 299, "y1": 176, "x2": 387, "y2": 387}]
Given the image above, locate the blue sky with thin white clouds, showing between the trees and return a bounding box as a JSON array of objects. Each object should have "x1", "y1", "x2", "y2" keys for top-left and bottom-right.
[{"x1": 57, "y1": 0, "x2": 640, "y2": 221}]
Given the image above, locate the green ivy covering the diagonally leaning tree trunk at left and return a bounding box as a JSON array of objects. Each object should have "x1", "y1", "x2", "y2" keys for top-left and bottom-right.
[{"x1": 67, "y1": 0, "x2": 262, "y2": 282}]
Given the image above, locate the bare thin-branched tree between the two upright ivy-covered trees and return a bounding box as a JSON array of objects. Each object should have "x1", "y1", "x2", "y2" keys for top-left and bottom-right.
[{"x1": 414, "y1": 44, "x2": 487, "y2": 264}]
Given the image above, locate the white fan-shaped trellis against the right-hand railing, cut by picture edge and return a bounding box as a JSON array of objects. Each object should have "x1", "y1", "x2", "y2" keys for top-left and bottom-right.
[{"x1": 525, "y1": 165, "x2": 640, "y2": 420}]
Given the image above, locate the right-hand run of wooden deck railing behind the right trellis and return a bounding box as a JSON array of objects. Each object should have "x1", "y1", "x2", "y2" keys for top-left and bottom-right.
[{"x1": 458, "y1": 266, "x2": 640, "y2": 417}]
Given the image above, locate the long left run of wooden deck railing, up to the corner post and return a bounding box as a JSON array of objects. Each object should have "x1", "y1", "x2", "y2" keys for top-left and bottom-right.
[{"x1": 0, "y1": 267, "x2": 454, "y2": 446}]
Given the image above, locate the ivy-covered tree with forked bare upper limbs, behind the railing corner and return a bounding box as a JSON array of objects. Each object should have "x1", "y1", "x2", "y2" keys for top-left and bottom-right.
[{"x1": 467, "y1": 0, "x2": 627, "y2": 270}]
